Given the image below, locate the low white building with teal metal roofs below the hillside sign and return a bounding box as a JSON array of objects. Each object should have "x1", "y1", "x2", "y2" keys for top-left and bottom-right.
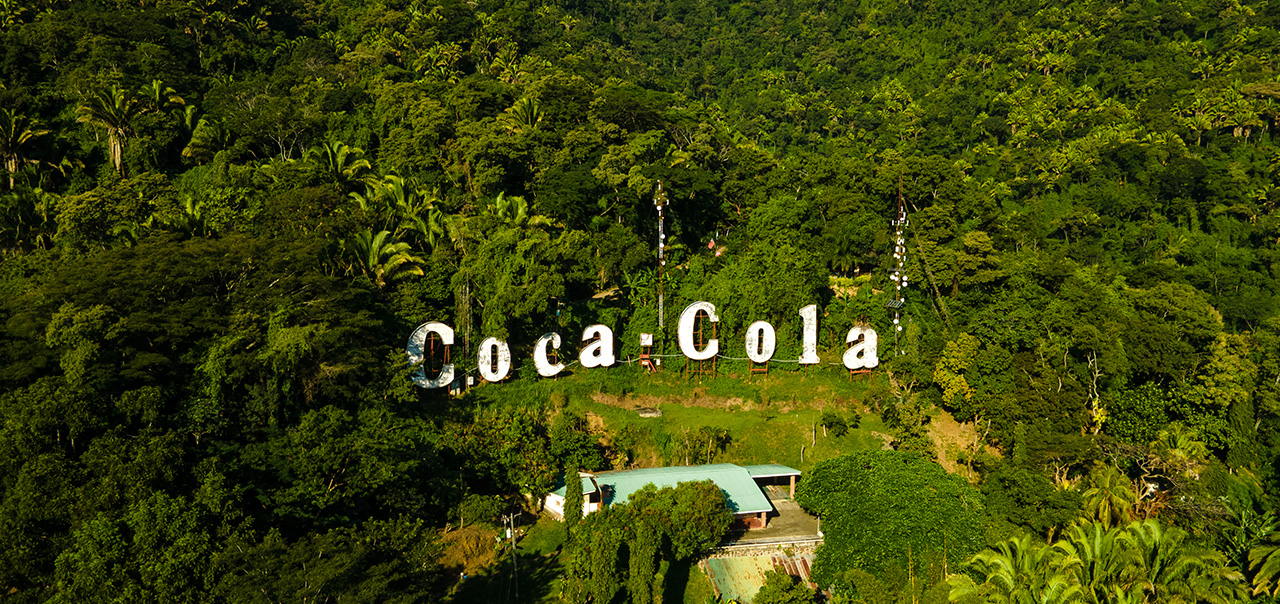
[{"x1": 545, "y1": 463, "x2": 800, "y2": 529}]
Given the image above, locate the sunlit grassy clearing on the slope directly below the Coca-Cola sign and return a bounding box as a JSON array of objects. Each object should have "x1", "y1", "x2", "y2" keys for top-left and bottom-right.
[{"x1": 468, "y1": 360, "x2": 888, "y2": 470}]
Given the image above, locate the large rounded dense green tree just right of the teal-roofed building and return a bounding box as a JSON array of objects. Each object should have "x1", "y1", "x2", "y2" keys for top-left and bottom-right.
[{"x1": 796, "y1": 450, "x2": 983, "y2": 585}]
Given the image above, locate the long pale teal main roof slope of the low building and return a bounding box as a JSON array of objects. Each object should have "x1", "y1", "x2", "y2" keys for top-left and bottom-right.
[{"x1": 595, "y1": 463, "x2": 773, "y2": 514}]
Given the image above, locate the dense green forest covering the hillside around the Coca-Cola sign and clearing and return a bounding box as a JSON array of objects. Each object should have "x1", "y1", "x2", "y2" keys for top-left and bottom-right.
[{"x1": 0, "y1": 0, "x2": 1280, "y2": 604}]
